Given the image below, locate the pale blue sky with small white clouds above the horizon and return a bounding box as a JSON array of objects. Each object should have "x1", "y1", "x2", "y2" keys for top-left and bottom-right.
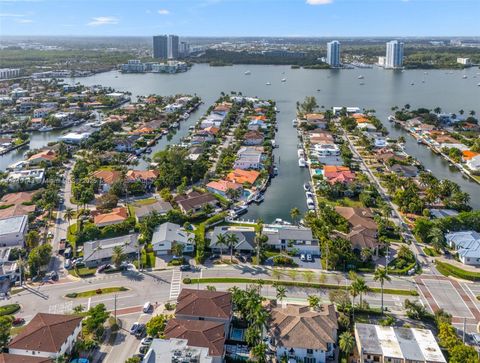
[{"x1": 0, "y1": 0, "x2": 480, "y2": 37}]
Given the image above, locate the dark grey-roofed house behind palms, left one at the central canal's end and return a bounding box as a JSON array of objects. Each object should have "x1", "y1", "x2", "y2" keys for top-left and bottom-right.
[{"x1": 209, "y1": 226, "x2": 255, "y2": 253}]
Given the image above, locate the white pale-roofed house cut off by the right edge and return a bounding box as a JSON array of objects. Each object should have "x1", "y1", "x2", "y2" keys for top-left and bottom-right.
[{"x1": 445, "y1": 231, "x2": 480, "y2": 266}]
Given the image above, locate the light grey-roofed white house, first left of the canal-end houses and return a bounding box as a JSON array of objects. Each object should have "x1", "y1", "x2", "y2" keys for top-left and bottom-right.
[{"x1": 152, "y1": 222, "x2": 195, "y2": 255}]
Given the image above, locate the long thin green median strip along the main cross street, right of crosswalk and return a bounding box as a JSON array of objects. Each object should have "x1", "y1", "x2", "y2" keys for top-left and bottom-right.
[{"x1": 183, "y1": 277, "x2": 418, "y2": 296}]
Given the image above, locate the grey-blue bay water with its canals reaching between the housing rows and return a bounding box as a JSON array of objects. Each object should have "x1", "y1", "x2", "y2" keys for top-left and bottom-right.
[{"x1": 0, "y1": 65, "x2": 480, "y2": 222}]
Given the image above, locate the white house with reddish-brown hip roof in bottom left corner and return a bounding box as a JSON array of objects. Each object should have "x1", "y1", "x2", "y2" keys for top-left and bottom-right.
[{"x1": 8, "y1": 313, "x2": 83, "y2": 363}]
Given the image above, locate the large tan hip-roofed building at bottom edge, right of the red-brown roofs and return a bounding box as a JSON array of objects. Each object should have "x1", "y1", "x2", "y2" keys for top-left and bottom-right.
[{"x1": 268, "y1": 304, "x2": 338, "y2": 363}]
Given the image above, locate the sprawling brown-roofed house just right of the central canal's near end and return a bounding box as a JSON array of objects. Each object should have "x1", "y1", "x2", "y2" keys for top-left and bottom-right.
[{"x1": 335, "y1": 207, "x2": 380, "y2": 257}]
